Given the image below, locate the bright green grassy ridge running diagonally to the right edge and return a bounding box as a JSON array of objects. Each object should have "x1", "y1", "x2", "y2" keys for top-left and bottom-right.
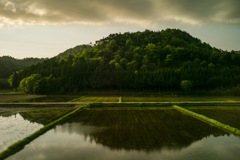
[{"x1": 172, "y1": 105, "x2": 240, "y2": 136}]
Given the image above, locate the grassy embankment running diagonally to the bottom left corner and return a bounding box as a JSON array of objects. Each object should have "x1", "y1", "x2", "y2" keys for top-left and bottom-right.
[{"x1": 0, "y1": 105, "x2": 87, "y2": 160}]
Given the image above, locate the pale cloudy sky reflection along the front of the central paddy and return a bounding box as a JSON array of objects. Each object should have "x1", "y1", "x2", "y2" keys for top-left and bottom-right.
[{"x1": 8, "y1": 123, "x2": 240, "y2": 160}]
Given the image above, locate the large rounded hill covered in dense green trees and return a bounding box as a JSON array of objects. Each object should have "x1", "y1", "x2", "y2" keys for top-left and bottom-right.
[{"x1": 10, "y1": 29, "x2": 240, "y2": 94}]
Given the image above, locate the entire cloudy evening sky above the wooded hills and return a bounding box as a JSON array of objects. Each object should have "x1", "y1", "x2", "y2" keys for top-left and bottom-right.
[{"x1": 0, "y1": 0, "x2": 240, "y2": 59}]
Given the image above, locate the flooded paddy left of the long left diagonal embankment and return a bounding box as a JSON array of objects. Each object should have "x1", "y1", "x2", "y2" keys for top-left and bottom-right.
[{"x1": 0, "y1": 106, "x2": 72, "y2": 152}]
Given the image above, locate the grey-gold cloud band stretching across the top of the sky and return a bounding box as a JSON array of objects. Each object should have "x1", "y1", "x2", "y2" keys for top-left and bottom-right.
[{"x1": 0, "y1": 0, "x2": 240, "y2": 25}]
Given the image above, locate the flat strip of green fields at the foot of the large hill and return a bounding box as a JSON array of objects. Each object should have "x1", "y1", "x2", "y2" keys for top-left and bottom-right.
[{"x1": 0, "y1": 92, "x2": 240, "y2": 103}]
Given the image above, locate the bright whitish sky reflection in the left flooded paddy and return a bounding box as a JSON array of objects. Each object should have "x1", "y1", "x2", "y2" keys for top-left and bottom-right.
[{"x1": 0, "y1": 114, "x2": 43, "y2": 152}]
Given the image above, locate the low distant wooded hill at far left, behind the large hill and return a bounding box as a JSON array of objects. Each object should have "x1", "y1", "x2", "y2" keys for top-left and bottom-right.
[{"x1": 0, "y1": 56, "x2": 44, "y2": 78}]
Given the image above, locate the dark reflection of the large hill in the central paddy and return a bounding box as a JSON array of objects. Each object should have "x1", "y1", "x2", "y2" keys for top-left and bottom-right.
[{"x1": 62, "y1": 108, "x2": 226, "y2": 150}]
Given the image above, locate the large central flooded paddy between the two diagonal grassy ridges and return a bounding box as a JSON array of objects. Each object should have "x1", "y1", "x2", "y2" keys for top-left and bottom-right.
[{"x1": 3, "y1": 107, "x2": 240, "y2": 160}]
